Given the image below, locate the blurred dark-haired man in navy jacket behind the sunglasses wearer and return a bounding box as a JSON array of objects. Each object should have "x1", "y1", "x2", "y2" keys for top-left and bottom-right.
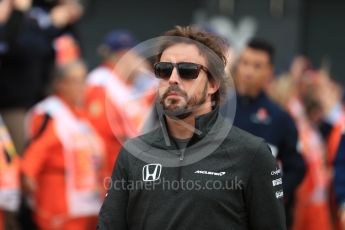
[{"x1": 223, "y1": 39, "x2": 305, "y2": 226}]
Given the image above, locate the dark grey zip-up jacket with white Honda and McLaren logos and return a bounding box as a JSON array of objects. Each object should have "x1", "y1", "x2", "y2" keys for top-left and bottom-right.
[{"x1": 98, "y1": 109, "x2": 286, "y2": 230}]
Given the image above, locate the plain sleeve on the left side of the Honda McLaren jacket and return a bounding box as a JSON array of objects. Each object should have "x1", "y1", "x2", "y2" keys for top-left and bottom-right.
[{"x1": 97, "y1": 149, "x2": 129, "y2": 230}]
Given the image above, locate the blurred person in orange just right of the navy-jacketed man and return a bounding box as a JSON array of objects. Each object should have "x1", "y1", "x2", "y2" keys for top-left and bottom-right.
[{"x1": 271, "y1": 72, "x2": 333, "y2": 230}]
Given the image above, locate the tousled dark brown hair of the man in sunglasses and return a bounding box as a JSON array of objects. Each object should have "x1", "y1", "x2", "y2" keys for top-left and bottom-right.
[{"x1": 156, "y1": 26, "x2": 229, "y2": 105}]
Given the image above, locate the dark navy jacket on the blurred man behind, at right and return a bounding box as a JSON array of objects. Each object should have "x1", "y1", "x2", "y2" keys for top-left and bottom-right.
[{"x1": 225, "y1": 92, "x2": 306, "y2": 226}]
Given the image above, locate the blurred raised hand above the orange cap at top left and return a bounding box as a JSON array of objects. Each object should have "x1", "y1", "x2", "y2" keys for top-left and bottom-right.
[{"x1": 50, "y1": 1, "x2": 83, "y2": 28}]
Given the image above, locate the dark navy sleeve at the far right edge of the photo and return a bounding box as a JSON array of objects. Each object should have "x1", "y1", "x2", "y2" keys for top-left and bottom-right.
[{"x1": 334, "y1": 134, "x2": 345, "y2": 208}]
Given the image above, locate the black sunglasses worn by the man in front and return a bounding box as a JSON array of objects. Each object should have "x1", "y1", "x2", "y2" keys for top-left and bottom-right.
[{"x1": 154, "y1": 62, "x2": 209, "y2": 79}]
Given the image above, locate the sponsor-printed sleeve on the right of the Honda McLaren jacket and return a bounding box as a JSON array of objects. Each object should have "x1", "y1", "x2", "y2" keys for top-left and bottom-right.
[{"x1": 245, "y1": 142, "x2": 286, "y2": 230}]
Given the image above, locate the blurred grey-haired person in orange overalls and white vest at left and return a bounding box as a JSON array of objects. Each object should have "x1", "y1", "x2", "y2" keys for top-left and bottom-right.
[{"x1": 21, "y1": 60, "x2": 105, "y2": 230}]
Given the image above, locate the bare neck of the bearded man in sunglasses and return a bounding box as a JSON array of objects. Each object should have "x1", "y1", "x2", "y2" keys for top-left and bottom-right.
[{"x1": 166, "y1": 98, "x2": 212, "y2": 140}]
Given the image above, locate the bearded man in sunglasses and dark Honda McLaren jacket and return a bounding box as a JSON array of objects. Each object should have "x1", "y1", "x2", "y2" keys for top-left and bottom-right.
[{"x1": 98, "y1": 27, "x2": 286, "y2": 230}]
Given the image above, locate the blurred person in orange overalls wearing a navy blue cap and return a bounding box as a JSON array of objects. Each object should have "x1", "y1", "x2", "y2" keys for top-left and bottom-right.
[{"x1": 86, "y1": 30, "x2": 156, "y2": 176}]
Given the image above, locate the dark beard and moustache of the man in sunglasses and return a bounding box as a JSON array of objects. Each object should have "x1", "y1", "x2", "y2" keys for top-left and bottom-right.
[{"x1": 160, "y1": 82, "x2": 208, "y2": 119}]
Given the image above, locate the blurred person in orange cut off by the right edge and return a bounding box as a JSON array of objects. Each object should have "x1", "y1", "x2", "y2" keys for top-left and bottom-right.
[{"x1": 314, "y1": 70, "x2": 345, "y2": 230}]
